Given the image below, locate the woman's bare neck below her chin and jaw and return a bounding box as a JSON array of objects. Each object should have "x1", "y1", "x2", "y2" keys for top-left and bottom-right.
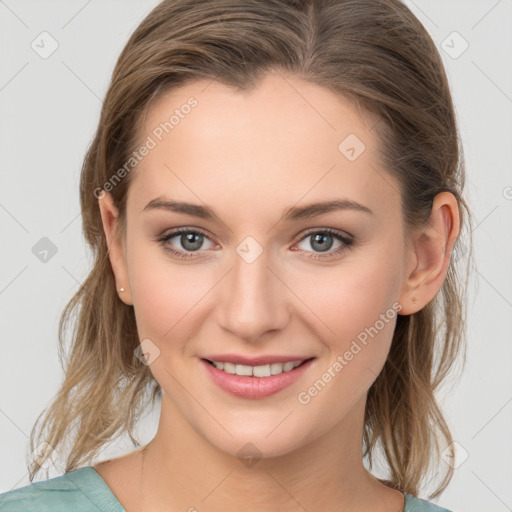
[{"x1": 140, "y1": 395, "x2": 404, "y2": 512}]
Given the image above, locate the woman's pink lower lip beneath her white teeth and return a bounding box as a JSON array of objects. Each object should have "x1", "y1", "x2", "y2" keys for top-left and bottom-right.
[{"x1": 201, "y1": 358, "x2": 314, "y2": 399}]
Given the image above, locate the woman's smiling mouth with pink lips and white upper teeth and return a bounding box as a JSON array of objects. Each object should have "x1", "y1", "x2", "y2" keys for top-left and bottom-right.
[{"x1": 200, "y1": 357, "x2": 316, "y2": 399}]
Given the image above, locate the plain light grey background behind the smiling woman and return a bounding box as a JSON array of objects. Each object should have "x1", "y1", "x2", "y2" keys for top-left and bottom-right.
[{"x1": 0, "y1": 0, "x2": 512, "y2": 512}]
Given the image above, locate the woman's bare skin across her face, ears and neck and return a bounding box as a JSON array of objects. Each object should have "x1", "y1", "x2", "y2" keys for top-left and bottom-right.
[{"x1": 95, "y1": 73, "x2": 459, "y2": 512}]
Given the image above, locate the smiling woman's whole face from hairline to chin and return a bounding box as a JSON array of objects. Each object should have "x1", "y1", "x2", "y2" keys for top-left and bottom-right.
[{"x1": 107, "y1": 74, "x2": 408, "y2": 456}]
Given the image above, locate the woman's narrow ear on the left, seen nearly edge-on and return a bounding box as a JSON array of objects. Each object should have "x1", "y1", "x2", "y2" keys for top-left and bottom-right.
[{"x1": 98, "y1": 191, "x2": 133, "y2": 306}]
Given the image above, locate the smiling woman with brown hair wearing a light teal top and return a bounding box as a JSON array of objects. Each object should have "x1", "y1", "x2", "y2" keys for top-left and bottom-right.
[{"x1": 0, "y1": 0, "x2": 470, "y2": 512}]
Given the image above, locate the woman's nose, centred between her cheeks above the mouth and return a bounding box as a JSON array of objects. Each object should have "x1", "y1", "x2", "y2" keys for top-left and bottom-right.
[{"x1": 217, "y1": 246, "x2": 290, "y2": 342}]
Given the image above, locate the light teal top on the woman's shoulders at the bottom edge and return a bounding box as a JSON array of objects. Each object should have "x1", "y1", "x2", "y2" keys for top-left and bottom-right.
[{"x1": 0, "y1": 466, "x2": 450, "y2": 512}]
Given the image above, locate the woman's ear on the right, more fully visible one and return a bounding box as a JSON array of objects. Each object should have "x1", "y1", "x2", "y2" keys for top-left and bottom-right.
[{"x1": 399, "y1": 191, "x2": 460, "y2": 315}]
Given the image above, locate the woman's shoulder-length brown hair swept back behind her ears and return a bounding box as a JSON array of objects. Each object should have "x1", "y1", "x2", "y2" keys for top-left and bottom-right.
[{"x1": 29, "y1": 0, "x2": 472, "y2": 497}]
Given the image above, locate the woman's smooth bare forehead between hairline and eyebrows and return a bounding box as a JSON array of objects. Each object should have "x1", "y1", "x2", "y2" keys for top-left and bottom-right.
[{"x1": 128, "y1": 74, "x2": 399, "y2": 222}]
